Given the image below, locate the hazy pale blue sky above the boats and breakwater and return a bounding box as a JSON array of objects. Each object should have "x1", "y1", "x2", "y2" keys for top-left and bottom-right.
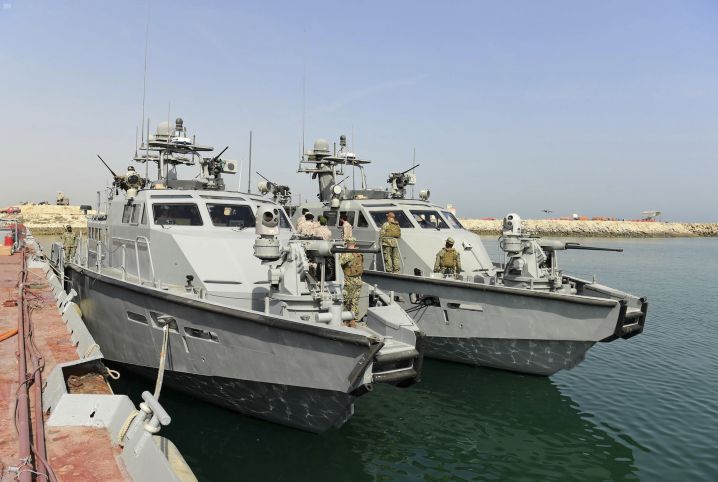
[{"x1": 0, "y1": 0, "x2": 718, "y2": 221}]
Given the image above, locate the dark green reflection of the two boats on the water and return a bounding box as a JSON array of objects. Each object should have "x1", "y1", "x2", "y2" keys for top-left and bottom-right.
[{"x1": 109, "y1": 360, "x2": 636, "y2": 480}]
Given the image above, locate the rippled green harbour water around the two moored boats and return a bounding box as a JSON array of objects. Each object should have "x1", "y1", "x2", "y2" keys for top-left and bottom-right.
[{"x1": 81, "y1": 235, "x2": 718, "y2": 481}]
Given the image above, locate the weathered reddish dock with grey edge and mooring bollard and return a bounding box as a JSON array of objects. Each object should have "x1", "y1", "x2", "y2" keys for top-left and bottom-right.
[{"x1": 0, "y1": 235, "x2": 197, "y2": 482}]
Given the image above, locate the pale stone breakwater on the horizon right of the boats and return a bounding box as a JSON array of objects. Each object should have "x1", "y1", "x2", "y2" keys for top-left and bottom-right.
[{"x1": 461, "y1": 219, "x2": 718, "y2": 238}]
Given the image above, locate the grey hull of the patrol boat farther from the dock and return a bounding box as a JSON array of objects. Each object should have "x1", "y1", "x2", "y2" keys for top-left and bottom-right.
[{"x1": 364, "y1": 271, "x2": 647, "y2": 376}]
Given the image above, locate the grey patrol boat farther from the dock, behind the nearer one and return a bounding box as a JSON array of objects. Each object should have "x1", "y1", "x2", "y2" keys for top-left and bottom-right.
[{"x1": 284, "y1": 136, "x2": 648, "y2": 375}]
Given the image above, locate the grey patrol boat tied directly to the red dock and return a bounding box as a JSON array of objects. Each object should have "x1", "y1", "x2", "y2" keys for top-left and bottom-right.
[{"x1": 64, "y1": 119, "x2": 422, "y2": 432}]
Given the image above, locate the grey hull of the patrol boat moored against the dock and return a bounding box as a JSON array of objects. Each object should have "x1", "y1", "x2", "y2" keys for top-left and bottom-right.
[{"x1": 66, "y1": 265, "x2": 383, "y2": 432}]
